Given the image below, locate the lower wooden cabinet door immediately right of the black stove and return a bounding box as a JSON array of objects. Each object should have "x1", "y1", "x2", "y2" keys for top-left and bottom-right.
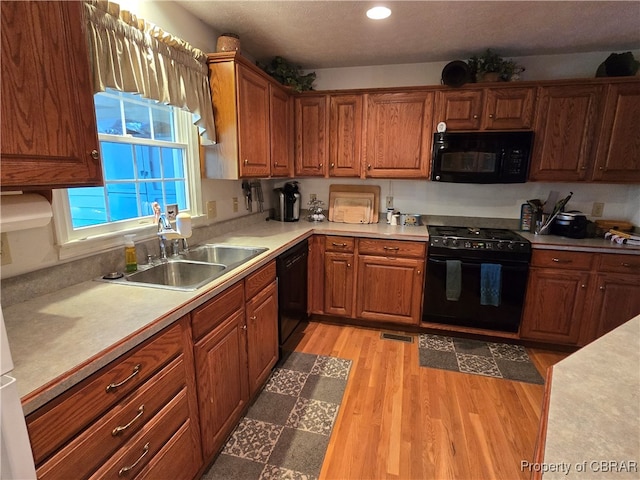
[{"x1": 520, "y1": 268, "x2": 589, "y2": 344}]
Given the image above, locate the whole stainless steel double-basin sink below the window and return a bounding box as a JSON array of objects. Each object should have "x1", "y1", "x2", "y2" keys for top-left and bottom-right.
[{"x1": 103, "y1": 244, "x2": 268, "y2": 291}]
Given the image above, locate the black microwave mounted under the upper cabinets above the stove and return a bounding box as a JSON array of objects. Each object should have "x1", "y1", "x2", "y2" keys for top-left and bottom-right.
[{"x1": 431, "y1": 132, "x2": 533, "y2": 183}]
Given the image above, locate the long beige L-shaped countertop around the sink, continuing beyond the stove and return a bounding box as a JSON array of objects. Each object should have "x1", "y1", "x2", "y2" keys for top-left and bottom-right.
[{"x1": 3, "y1": 220, "x2": 640, "y2": 414}]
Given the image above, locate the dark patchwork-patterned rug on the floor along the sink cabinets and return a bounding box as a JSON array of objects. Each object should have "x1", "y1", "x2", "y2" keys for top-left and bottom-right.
[{"x1": 202, "y1": 352, "x2": 351, "y2": 480}]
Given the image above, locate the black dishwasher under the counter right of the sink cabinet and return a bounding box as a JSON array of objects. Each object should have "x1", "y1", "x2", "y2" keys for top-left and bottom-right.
[{"x1": 276, "y1": 240, "x2": 309, "y2": 347}]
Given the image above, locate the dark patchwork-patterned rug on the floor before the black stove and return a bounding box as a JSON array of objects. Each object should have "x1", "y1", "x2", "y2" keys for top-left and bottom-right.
[{"x1": 418, "y1": 334, "x2": 544, "y2": 385}]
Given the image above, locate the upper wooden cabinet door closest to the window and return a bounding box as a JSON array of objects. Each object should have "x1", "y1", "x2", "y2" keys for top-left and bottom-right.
[{"x1": 237, "y1": 65, "x2": 271, "y2": 177}]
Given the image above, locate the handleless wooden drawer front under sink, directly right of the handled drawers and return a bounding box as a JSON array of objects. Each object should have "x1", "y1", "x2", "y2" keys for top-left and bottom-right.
[{"x1": 191, "y1": 282, "x2": 244, "y2": 341}]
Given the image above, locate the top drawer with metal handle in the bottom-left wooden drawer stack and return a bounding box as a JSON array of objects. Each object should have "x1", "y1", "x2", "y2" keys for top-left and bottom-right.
[{"x1": 27, "y1": 322, "x2": 182, "y2": 465}]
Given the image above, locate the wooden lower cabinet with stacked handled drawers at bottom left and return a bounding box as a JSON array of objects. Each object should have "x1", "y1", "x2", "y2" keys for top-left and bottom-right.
[{"x1": 27, "y1": 316, "x2": 202, "y2": 479}]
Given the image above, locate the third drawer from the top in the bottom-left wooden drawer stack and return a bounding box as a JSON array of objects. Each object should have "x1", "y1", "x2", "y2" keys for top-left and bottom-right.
[{"x1": 89, "y1": 388, "x2": 192, "y2": 480}]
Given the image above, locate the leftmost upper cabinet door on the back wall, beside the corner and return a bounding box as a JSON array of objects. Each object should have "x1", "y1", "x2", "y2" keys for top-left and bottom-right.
[{"x1": 295, "y1": 95, "x2": 328, "y2": 176}]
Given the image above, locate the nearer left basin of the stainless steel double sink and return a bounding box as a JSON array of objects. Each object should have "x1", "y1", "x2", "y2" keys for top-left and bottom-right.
[{"x1": 116, "y1": 260, "x2": 227, "y2": 290}]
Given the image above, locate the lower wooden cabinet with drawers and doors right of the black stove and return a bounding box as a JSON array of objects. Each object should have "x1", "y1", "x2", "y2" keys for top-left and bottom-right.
[{"x1": 520, "y1": 250, "x2": 640, "y2": 345}]
